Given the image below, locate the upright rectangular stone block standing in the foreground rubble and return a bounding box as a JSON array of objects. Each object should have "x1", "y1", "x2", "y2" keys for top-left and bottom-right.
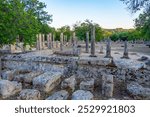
[{"x1": 102, "y1": 75, "x2": 114, "y2": 98}]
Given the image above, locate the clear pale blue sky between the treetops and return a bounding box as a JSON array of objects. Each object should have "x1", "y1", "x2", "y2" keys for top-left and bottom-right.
[{"x1": 40, "y1": 0, "x2": 137, "y2": 28}]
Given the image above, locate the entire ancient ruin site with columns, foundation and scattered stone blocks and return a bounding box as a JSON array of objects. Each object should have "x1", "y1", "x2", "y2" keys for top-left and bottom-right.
[{"x1": 0, "y1": 29, "x2": 150, "y2": 100}]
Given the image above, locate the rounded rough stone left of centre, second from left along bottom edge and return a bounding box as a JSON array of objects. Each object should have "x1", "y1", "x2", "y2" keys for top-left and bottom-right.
[{"x1": 18, "y1": 89, "x2": 40, "y2": 100}]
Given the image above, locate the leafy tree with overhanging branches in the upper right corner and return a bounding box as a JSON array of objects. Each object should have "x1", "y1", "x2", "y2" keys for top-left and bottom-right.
[{"x1": 121, "y1": 0, "x2": 150, "y2": 40}]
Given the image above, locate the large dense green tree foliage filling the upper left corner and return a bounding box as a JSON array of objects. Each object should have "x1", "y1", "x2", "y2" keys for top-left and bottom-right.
[{"x1": 0, "y1": 0, "x2": 52, "y2": 45}]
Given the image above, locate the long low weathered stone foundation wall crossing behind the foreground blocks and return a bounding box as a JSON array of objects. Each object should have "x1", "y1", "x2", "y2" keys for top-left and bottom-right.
[{"x1": 2, "y1": 55, "x2": 150, "y2": 97}]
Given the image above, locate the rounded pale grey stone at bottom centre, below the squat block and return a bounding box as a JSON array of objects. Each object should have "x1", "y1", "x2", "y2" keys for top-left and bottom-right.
[{"x1": 72, "y1": 90, "x2": 94, "y2": 100}]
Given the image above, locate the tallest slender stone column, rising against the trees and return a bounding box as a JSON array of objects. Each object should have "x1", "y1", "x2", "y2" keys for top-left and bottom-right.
[{"x1": 90, "y1": 26, "x2": 96, "y2": 57}]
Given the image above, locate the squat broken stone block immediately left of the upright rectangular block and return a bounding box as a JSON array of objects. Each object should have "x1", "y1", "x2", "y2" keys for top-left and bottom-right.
[{"x1": 80, "y1": 79, "x2": 94, "y2": 92}]
